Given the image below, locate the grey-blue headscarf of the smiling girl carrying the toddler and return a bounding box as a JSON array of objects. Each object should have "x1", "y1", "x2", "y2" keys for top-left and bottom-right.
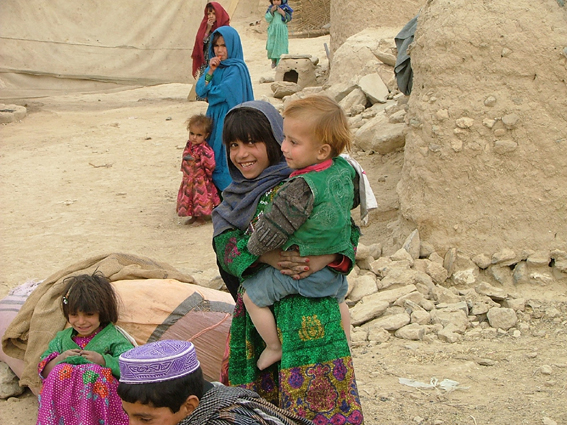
[{"x1": 212, "y1": 100, "x2": 291, "y2": 237}]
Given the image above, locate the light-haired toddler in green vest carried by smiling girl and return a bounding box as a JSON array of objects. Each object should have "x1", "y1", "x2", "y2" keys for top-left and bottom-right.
[{"x1": 242, "y1": 96, "x2": 356, "y2": 370}]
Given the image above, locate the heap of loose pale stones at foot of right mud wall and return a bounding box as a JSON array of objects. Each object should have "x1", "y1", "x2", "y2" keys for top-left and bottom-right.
[{"x1": 347, "y1": 231, "x2": 567, "y2": 345}]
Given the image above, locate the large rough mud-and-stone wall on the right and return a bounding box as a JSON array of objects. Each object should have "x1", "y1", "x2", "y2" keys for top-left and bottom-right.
[{"x1": 398, "y1": 0, "x2": 567, "y2": 262}]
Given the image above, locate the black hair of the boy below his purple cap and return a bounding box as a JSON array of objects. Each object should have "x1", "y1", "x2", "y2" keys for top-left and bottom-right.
[{"x1": 117, "y1": 367, "x2": 205, "y2": 413}]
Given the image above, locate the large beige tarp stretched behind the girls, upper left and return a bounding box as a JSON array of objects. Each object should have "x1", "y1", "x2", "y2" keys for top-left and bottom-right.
[{"x1": 0, "y1": 0, "x2": 248, "y2": 99}]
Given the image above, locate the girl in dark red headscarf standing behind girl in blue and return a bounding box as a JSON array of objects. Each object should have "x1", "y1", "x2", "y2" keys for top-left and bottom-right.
[{"x1": 191, "y1": 1, "x2": 230, "y2": 100}]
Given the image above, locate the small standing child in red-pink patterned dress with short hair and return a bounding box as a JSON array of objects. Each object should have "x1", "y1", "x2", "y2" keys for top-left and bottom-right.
[{"x1": 177, "y1": 114, "x2": 220, "y2": 226}]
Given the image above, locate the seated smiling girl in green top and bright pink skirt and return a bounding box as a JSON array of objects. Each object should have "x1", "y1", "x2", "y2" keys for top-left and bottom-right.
[{"x1": 37, "y1": 272, "x2": 133, "y2": 425}]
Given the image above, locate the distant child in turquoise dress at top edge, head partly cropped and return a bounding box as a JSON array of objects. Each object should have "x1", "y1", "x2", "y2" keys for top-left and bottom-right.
[{"x1": 264, "y1": 0, "x2": 293, "y2": 68}]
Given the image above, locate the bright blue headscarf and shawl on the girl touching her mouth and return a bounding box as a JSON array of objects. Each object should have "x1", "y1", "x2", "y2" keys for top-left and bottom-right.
[{"x1": 207, "y1": 26, "x2": 254, "y2": 108}]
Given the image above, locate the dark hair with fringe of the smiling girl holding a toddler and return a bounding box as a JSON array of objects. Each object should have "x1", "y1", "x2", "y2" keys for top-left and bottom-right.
[{"x1": 222, "y1": 107, "x2": 283, "y2": 165}]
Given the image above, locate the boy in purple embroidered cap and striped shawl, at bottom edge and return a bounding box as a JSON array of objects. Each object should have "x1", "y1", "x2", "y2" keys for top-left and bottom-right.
[{"x1": 118, "y1": 340, "x2": 314, "y2": 425}]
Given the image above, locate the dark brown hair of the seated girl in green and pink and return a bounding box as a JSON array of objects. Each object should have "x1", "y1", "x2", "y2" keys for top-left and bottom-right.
[{"x1": 61, "y1": 271, "x2": 118, "y2": 326}]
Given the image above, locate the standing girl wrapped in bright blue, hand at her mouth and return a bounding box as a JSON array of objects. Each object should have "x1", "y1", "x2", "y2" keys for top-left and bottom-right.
[{"x1": 195, "y1": 26, "x2": 254, "y2": 192}]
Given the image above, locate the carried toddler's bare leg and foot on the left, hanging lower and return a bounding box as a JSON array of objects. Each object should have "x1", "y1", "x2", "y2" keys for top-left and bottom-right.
[{"x1": 242, "y1": 293, "x2": 282, "y2": 370}]
